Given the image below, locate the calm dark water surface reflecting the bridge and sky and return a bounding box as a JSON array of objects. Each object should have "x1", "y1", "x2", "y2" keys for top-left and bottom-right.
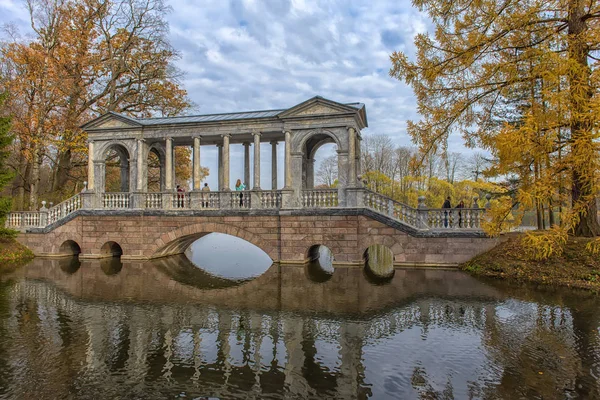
[{"x1": 0, "y1": 244, "x2": 600, "y2": 399}]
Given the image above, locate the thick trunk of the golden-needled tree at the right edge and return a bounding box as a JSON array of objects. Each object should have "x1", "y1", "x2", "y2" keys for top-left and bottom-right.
[{"x1": 568, "y1": 0, "x2": 600, "y2": 237}]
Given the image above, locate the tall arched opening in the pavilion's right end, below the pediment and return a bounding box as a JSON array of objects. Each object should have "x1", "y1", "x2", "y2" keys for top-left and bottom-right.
[{"x1": 302, "y1": 133, "x2": 339, "y2": 189}]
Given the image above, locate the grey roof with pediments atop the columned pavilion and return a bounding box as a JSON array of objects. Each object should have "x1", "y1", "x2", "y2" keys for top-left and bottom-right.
[{"x1": 81, "y1": 96, "x2": 367, "y2": 129}]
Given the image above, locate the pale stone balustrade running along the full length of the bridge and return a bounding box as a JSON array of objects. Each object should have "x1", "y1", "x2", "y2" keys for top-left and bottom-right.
[{"x1": 6, "y1": 187, "x2": 489, "y2": 232}]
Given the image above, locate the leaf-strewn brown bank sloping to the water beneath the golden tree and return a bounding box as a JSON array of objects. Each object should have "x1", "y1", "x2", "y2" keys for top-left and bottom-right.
[{"x1": 460, "y1": 235, "x2": 600, "y2": 292}]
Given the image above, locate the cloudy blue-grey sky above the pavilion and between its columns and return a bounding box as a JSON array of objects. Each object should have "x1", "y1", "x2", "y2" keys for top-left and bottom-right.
[{"x1": 0, "y1": 0, "x2": 461, "y2": 188}]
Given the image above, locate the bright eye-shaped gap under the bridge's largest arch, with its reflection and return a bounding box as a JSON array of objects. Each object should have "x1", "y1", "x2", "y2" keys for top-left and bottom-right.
[{"x1": 182, "y1": 233, "x2": 273, "y2": 281}]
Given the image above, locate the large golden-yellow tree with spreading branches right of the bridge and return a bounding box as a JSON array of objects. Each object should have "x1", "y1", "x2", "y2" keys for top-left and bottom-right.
[{"x1": 390, "y1": 0, "x2": 600, "y2": 236}]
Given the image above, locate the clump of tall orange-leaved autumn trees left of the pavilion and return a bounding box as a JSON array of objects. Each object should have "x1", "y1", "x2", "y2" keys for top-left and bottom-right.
[{"x1": 1, "y1": 0, "x2": 190, "y2": 208}]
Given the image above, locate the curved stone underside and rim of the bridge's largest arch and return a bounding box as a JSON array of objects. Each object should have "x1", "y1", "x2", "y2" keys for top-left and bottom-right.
[{"x1": 148, "y1": 223, "x2": 279, "y2": 261}]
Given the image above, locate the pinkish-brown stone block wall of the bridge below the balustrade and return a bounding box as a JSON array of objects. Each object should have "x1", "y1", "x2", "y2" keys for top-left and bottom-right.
[{"x1": 19, "y1": 210, "x2": 498, "y2": 265}]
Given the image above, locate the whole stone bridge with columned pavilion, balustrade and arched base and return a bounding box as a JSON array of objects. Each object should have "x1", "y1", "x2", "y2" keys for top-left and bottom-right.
[{"x1": 6, "y1": 97, "x2": 497, "y2": 265}]
